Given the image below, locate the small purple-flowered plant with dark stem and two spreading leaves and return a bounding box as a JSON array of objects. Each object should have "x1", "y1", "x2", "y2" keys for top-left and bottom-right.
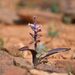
[{"x1": 19, "y1": 17, "x2": 70, "y2": 66}]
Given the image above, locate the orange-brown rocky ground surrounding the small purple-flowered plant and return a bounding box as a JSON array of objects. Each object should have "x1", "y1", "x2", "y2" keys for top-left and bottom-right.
[{"x1": 0, "y1": 0, "x2": 75, "y2": 75}]
